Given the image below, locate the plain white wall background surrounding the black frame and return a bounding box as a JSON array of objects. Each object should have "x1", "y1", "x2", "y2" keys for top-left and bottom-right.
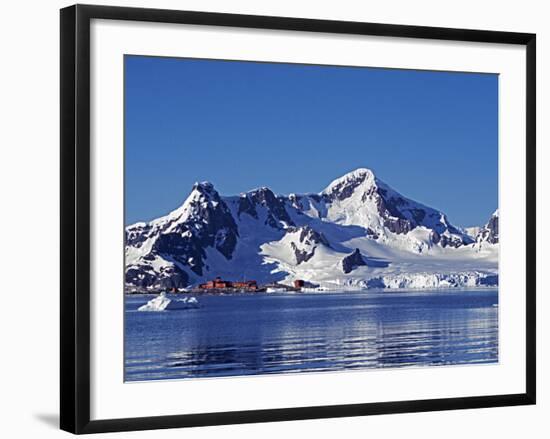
[{"x1": 0, "y1": 0, "x2": 550, "y2": 439}]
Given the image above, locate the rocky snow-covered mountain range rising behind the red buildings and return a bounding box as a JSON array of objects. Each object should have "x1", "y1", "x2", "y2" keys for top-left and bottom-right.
[{"x1": 126, "y1": 168, "x2": 498, "y2": 288}]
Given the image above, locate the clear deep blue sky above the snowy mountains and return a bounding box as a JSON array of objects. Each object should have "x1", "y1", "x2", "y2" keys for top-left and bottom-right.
[{"x1": 125, "y1": 56, "x2": 498, "y2": 226}]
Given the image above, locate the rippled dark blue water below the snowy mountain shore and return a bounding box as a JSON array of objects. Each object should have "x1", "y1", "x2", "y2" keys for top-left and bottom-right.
[{"x1": 125, "y1": 290, "x2": 498, "y2": 381}]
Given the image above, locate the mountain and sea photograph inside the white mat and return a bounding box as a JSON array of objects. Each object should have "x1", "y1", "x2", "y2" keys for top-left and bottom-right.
[{"x1": 124, "y1": 54, "x2": 499, "y2": 382}]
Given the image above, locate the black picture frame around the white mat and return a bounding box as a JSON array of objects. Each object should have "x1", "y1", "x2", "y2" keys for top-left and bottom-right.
[{"x1": 60, "y1": 5, "x2": 536, "y2": 434}]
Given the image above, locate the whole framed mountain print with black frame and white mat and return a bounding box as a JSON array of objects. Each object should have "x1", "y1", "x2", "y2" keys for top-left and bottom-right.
[{"x1": 61, "y1": 5, "x2": 535, "y2": 433}]
